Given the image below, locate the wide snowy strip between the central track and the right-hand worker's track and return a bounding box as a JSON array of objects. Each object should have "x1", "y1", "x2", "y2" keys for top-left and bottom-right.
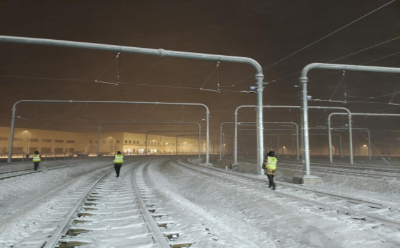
[{"x1": 143, "y1": 159, "x2": 400, "y2": 248}]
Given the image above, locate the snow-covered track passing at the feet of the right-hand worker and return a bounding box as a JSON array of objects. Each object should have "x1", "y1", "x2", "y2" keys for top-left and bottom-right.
[{"x1": 177, "y1": 160, "x2": 400, "y2": 231}]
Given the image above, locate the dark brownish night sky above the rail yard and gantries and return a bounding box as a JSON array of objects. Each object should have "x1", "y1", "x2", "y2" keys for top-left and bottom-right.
[{"x1": 0, "y1": 0, "x2": 400, "y2": 149}]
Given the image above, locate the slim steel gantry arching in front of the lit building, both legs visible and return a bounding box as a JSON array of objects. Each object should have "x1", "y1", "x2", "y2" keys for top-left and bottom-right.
[{"x1": 7, "y1": 100, "x2": 211, "y2": 165}]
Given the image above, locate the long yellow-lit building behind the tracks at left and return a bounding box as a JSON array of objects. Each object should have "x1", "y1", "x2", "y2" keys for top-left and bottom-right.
[{"x1": 0, "y1": 127, "x2": 205, "y2": 158}]
